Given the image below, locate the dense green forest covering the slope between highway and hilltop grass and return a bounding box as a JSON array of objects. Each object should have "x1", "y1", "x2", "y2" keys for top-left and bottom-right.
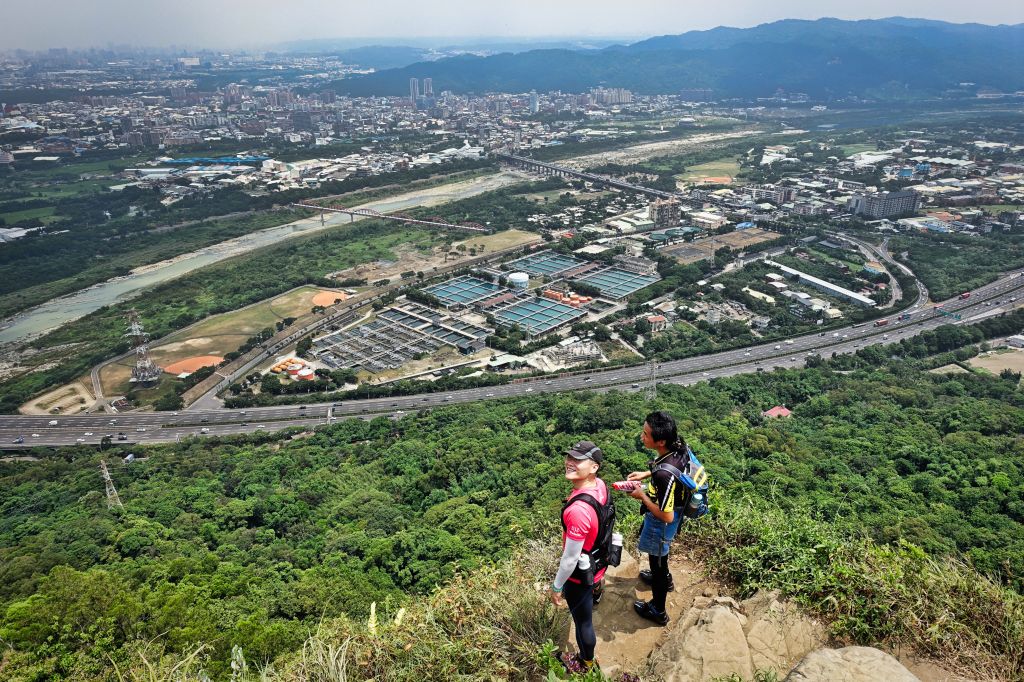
[{"x1": 0, "y1": 353, "x2": 1024, "y2": 679}]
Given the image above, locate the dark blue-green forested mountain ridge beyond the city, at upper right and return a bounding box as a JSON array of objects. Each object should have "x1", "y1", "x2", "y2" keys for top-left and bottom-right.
[{"x1": 333, "y1": 17, "x2": 1024, "y2": 98}]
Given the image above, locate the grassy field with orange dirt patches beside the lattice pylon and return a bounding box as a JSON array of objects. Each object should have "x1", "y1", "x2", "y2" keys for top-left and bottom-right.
[{"x1": 99, "y1": 287, "x2": 345, "y2": 396}]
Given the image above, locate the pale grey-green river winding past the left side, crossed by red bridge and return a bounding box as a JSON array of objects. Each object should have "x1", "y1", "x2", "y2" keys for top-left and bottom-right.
[{"x1": 0, "y1": 172, "x2": 524, "y2": 345}]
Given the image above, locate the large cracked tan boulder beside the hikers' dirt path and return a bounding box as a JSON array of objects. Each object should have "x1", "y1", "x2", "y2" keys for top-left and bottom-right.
[{"x1": 651, "y1": 592, "x2": 825, "y2": 682}]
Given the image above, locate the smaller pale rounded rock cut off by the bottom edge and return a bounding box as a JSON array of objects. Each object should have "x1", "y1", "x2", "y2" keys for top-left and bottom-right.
[{"x1": 783, "y1": 646, "x2": 920, "y2": 682}]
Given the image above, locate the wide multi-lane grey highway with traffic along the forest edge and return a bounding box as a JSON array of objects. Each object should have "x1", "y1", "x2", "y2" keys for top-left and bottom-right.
[{"x1": 0, "y1": 270, "x2": 1024, "y2": 450}]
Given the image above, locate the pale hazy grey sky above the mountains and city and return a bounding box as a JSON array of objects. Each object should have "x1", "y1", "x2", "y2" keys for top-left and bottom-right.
[{"x1": 0, "y1": 0, "x2": 1024, "y2": 49}]
